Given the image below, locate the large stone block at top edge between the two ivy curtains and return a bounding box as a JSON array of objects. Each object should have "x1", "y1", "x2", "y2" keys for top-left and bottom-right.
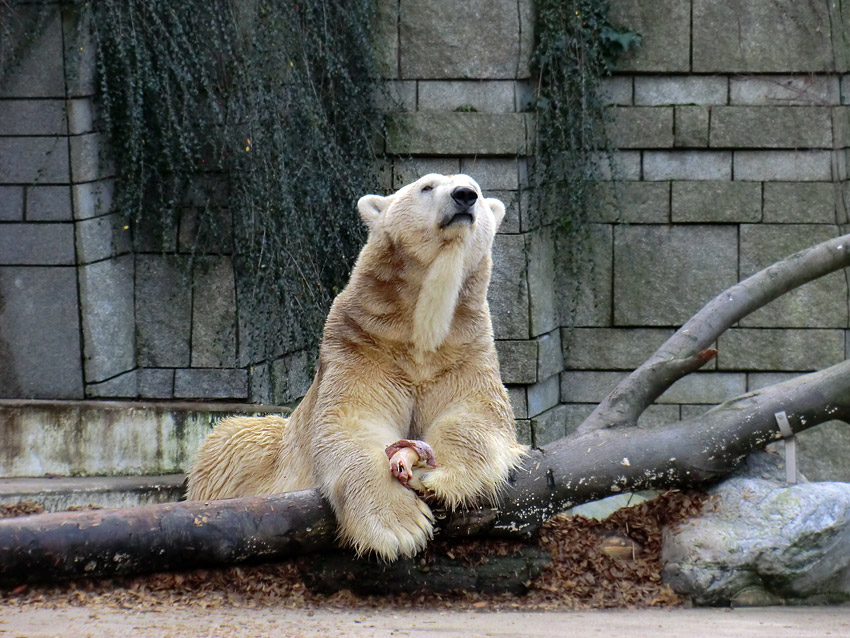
[{"x1": 399, "y1": 0, "x2": 534, "y2": 80}]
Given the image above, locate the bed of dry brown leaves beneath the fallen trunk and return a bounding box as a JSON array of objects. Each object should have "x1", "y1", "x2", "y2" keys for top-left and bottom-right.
[{"x1": 0, "y1": 492, "x2": 706, "y2": 611}]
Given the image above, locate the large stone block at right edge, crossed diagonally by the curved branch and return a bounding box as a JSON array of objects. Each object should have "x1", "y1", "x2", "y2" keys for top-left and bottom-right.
[{"x1": 740, "y1": 224, "x2": 848, "y2": 328}]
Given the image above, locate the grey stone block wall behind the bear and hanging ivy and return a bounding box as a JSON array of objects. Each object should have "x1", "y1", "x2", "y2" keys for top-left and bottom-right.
[{"x1": 0, "y1": 0, "x2": 850, "y2": 478}]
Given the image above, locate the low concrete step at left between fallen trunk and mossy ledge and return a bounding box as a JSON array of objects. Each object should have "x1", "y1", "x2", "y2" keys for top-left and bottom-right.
[{"x1": 0, "y1": 474, "x2": 186, "y2": 512}]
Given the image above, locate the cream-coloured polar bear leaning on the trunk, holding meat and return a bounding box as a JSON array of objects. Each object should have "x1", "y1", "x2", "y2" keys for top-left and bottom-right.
[{"x1": 187, "y1": 174, "x2": 525, "y2": 560}]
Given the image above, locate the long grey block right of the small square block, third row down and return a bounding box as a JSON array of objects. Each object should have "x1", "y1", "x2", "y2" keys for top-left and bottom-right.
[{"x1": 710, "y1": 106, "x2": 832, "y2": 149}]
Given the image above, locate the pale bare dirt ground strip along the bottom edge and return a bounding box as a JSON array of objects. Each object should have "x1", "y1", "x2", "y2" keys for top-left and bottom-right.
[{"x1": 0, "y1": 604, "x2": 850, "y2": 638}]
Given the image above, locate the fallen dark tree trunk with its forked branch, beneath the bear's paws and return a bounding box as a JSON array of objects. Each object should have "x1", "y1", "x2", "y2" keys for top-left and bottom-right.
[{"x1": 0, "y1": 235, "x2": 850, "y2": 585}]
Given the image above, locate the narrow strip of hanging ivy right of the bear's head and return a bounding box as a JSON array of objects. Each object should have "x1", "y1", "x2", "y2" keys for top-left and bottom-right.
[{"x1": 531, "y1": 0, "x2": 640, "y2": 230}]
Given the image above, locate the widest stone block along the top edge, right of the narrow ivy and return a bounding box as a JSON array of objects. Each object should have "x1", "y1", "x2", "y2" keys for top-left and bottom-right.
[{"x1": 693, "y1": 0, "x2": 834, "y2": 73}]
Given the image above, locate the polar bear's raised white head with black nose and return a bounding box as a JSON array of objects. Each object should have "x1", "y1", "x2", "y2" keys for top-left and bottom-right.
[{"x1": 357, "y1": 173, "x2": 505, "y2": 265}]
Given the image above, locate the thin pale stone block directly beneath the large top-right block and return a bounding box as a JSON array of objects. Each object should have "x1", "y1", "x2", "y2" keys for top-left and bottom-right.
[{"x1": 729, "y1": 74, "x2": 840, "y2": 106}]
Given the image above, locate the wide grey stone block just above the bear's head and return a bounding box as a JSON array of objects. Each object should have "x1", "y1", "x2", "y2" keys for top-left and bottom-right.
[{"x1": 387, "y1": 112, "x2": 530, "y2": 156}]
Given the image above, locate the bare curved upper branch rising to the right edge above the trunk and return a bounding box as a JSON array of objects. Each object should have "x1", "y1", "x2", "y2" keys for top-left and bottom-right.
[{"x1": 578, "y1": 235, "x2": 850, "y2": 432}]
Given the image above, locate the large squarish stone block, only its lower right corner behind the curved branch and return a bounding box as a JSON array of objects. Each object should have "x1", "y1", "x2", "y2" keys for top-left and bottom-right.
[{"x1": 614, "y1": 226, "x2": 738, "y2": 326}]
